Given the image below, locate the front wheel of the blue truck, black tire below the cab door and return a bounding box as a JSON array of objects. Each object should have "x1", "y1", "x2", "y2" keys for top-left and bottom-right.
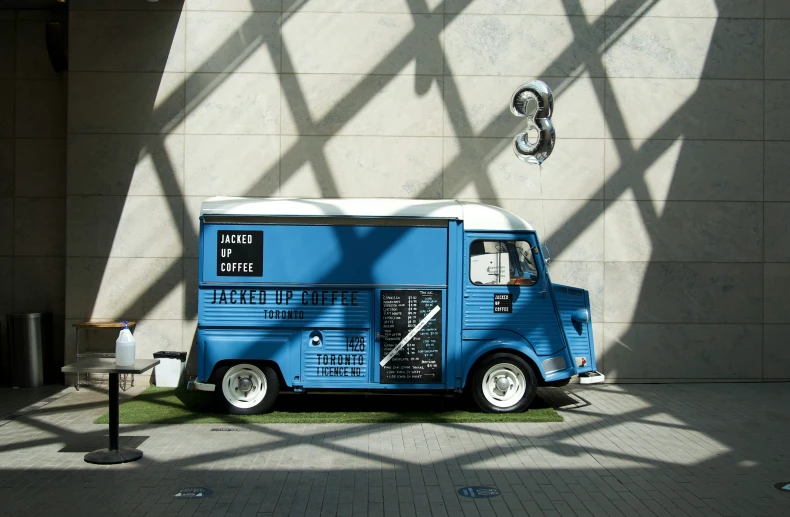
[{"x1": 471, "y1": 353, "x2": 538, "y2": 413}]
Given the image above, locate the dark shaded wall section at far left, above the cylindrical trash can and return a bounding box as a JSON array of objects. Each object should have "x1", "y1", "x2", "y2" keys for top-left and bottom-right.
[{"x1": 0, "y1": 11, "x2": 66, "y2": 374}]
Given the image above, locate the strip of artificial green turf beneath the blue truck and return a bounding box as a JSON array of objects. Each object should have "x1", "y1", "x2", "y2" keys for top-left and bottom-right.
[{"x1": 94, "y1": 386, "x2": 563, "y2": 424}]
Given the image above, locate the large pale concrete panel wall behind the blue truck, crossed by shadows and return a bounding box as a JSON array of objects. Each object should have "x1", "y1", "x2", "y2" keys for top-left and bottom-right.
[{"x1": 57, "y1": 0, "x2": 790, "y2": 381}]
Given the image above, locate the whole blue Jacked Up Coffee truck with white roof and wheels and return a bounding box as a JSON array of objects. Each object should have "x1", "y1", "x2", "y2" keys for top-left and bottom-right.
[{"x1": 190, "y1": 198, "x2": 604, "y2": 414}]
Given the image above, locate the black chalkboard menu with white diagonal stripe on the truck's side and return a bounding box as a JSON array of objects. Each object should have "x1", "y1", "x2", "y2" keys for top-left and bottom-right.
[{"x1": 379, "y1": 289, "x2": 443, "y2": 384}]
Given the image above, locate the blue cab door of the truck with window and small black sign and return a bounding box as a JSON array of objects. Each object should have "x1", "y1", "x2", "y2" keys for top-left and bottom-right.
[{"x1": 463, "y1": 233, "x2": 565, "y2": 355}]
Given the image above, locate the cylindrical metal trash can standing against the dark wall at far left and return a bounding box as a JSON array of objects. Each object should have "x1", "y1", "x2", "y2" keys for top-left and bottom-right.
[{"x1": 6, "y1": 312, "x2": 49, "y2": 388}]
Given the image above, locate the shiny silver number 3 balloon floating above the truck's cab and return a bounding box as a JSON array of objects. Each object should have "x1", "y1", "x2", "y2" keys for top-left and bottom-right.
[{"x1": 510, "y1": 81, "x2": 555, "y2": 164}]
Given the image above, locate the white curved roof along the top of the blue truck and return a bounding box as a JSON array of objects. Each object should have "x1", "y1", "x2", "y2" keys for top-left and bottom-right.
[{"x1": 200, "y1": 197, "x2": 533, "y2": 231}]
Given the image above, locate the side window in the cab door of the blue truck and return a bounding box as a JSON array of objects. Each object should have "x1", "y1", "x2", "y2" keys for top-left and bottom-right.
[{"x1": 469, "y1": 239, "x2": 538, "y2": 285}]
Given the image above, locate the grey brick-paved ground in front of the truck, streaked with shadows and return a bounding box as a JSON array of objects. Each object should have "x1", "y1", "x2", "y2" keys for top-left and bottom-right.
[{"x1": 0, "y1": 383, "x2": 790, "y2": 517}]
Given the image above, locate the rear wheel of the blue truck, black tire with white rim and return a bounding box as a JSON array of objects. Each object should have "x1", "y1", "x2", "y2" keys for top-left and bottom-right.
[{"x1": 214, "y1": 362, "x2": 280, "y2": 415}]
